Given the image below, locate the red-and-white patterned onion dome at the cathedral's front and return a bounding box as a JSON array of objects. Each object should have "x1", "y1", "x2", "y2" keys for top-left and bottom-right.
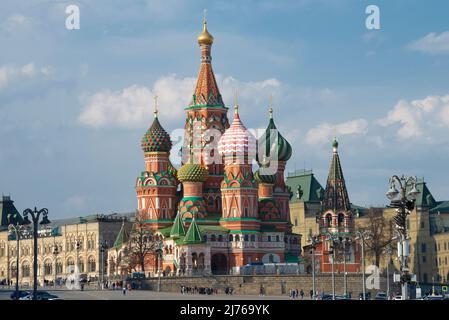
[{"x1": 218, "y1": 106, "x2": 256, "y2": 159}]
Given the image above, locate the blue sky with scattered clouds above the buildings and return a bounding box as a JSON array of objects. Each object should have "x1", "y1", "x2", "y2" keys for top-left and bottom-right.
[{"x1": 0, "y1": 0, "x2": 449, "y2": 219}]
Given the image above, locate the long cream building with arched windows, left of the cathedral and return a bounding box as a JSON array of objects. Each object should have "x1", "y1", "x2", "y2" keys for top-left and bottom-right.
[{"x1": 0, "y1": 197, "x2": 131, "y2": 286}]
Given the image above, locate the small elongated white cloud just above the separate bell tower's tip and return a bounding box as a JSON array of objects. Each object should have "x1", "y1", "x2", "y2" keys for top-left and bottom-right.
[{"x1": 306, "y1": 119, "x2": 368, "y2": 144}]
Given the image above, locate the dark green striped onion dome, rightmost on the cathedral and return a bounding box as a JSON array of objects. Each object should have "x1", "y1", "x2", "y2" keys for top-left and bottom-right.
[{"x1": 257, "y1": 107, "x2": 292, "y2": 162}]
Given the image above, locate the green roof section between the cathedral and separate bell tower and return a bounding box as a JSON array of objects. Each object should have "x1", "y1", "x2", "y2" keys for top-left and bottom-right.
[{"x1": 285, "y1": 170, "x2": 324, "y2": 202}]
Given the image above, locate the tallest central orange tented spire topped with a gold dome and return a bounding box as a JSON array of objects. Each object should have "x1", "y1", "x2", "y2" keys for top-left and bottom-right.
[{"x1": 189, "y1": 19, "x2": 225, "y2": 108}]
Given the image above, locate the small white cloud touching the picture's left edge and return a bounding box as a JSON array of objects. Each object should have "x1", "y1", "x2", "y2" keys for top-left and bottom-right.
[{"x1": 0, "y1": 62, "x2": 53, "y2": 89}]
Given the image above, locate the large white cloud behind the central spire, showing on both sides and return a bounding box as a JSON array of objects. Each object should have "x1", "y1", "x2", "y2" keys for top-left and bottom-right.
[{"x1": 78, "y1": 74, "x2": 281, "y2": 128}]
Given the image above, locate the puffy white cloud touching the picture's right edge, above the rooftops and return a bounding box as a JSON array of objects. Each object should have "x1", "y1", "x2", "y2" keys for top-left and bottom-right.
[{"x1": 377, "y1": 95, "x2": 449, "y2": 139}]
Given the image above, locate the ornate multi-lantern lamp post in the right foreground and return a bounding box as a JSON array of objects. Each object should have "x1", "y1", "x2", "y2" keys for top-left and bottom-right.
[{"x1": 386, "y1": 175, "x2": 420, "y2": 300}]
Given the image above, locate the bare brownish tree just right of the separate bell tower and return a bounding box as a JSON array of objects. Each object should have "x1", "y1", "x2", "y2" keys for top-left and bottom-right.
[{"x1": 360, "y1": 208, "x2": 392, "y2": 267}]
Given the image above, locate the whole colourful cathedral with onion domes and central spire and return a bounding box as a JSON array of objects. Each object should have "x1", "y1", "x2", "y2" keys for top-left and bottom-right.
[{"x1": 136, "y1": 17, "x2": 301, "y2": 275}]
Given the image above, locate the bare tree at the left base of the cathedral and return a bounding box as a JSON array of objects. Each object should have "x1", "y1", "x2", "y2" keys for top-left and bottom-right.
[{"x1": 128, "y1": 218, "x2": 161, "y2": 272}]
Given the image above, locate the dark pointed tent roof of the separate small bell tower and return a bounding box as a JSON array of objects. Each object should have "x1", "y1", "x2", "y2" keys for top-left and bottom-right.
[{"x1": 322, "y1": 138, "x2": 351, "y2": 212}]
